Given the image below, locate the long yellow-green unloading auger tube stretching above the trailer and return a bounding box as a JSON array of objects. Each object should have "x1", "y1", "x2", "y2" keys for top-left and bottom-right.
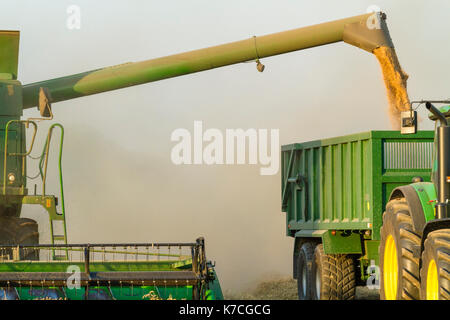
[{"x1": 23, "y1": 12, "x2": 393, "y2": 109}]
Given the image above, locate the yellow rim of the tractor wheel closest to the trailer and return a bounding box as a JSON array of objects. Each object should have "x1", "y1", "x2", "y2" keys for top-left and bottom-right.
[{"x1": 383, "y1": 235, "x2": 398, "y2": 300}]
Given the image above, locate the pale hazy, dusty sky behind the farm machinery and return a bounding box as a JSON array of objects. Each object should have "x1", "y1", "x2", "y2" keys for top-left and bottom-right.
[{"x1": 0, "y1": 0, "x2": 450, "y2": 289}]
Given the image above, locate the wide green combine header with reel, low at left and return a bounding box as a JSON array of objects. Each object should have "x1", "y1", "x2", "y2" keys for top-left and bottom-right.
[{"x1": 0, "y1": 238, "x2": 223, "y2": 300}]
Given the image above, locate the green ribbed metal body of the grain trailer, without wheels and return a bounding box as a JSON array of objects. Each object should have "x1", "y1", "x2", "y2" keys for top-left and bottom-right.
[{"x1": 281, "y1": 131, "x2": 435, "y2": 254}]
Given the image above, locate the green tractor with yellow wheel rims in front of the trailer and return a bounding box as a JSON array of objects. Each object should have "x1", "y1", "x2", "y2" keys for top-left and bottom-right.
[{"x1": 379, "y1": 101, "x2": 450, "y2": 300}]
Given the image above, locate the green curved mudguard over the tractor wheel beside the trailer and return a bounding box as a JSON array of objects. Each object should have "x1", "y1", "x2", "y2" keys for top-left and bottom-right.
[{"x1": 389, "y1": 182, "x2": 436, "y2": 236}]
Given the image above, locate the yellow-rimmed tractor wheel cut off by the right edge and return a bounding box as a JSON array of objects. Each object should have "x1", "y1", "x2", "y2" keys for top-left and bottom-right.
[{"x1": 420, "y1": 229, "x2": 450, "y2": 300}]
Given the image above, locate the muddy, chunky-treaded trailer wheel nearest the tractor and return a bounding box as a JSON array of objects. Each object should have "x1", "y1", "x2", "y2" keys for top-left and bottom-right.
[{"x1": 311, "y1": 244, "x2": 356, "y2": 300}]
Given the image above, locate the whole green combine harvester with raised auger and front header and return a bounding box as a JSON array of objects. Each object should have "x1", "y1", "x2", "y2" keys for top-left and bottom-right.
[{"x1": 0, "y1": 13, "x2": 406, "y2": 299}]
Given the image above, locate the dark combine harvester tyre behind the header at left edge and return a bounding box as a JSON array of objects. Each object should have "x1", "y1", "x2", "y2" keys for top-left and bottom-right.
[{"x1": 0, "y1": 217, "x2": 39, "y2": 260}]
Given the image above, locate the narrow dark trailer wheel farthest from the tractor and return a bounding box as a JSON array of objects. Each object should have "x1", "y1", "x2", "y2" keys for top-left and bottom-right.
[{"x1": 297, "y1": 242, "x2": 315, "y2": 300}]
